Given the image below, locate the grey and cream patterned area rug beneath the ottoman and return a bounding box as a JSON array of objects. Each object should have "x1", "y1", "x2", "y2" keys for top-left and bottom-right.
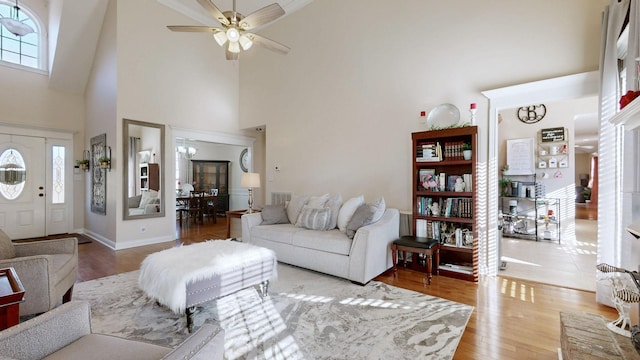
[{"x1": 73, "y1": 264, "x2": 473, "y2": 360}]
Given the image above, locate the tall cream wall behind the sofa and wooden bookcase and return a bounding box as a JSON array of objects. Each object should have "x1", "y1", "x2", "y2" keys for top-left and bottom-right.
[{"x1": 240, "y1": 0, "x2": 608, "y2": 210}]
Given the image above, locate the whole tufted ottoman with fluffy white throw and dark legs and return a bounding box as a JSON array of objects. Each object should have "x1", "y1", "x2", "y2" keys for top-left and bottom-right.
[{"x1": 138, "y1": 240, "x2": 277, "y2": 332}]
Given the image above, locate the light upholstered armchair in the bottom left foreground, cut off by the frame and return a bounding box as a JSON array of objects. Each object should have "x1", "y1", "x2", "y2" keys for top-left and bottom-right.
[{"x1": 0, "y1": 301, "x2": 224, "y2": 360}]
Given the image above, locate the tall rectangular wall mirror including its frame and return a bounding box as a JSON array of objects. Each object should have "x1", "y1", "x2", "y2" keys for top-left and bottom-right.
[{"x1": 122, "y1": 119, "x2": 166, "y2": 220}]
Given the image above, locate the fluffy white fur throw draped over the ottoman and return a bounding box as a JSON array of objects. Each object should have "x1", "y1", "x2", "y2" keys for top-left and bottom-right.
[{"x1": 138, "y1": 240, "x2": 277, "y2": 314}]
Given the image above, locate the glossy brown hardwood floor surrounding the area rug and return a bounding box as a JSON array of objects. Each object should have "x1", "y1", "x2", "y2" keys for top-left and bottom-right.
[{"x1": 78, "y1": 218, "x2": 617, "y2": 360}]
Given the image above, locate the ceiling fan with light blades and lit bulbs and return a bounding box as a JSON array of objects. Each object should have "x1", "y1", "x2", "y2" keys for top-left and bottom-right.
[{"x1": 167, "y1": 0, "x2": 290, "y2": 60}]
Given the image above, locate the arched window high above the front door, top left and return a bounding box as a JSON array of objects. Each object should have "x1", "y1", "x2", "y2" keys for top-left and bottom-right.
[{"x1": 0, "y1": 0, "x2": 43, "y2": 69}]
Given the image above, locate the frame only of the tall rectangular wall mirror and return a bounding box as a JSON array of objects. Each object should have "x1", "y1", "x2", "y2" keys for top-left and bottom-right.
[{"x1": 122, "y1": 118, "x2": 166, "y2": 220}]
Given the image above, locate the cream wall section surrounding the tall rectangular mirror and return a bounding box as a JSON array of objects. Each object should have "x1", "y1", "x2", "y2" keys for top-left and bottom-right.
[{"x1": 111, "y1": 0, "x2": 241, "y2": 249}]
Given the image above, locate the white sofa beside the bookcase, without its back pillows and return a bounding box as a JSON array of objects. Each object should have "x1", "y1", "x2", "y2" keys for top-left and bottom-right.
[{"x1": 242, "y1": 208, "x2": 400, "y2": 284}]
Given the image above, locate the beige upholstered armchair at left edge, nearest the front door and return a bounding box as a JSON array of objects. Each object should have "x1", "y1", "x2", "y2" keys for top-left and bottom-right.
[{"x1": 0, "y1": 230, "x2": 78, "y2": 316}]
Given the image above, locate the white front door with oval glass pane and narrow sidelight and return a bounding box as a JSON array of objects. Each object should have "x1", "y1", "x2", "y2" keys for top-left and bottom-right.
[{"x1": 0, "y1": 124, "x2": 73, "y2": 239}]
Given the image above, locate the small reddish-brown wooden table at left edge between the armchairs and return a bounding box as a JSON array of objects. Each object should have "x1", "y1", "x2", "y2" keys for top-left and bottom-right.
[{"x1": 0, "y1": 267, "x2": 24, "y2": 330}]
